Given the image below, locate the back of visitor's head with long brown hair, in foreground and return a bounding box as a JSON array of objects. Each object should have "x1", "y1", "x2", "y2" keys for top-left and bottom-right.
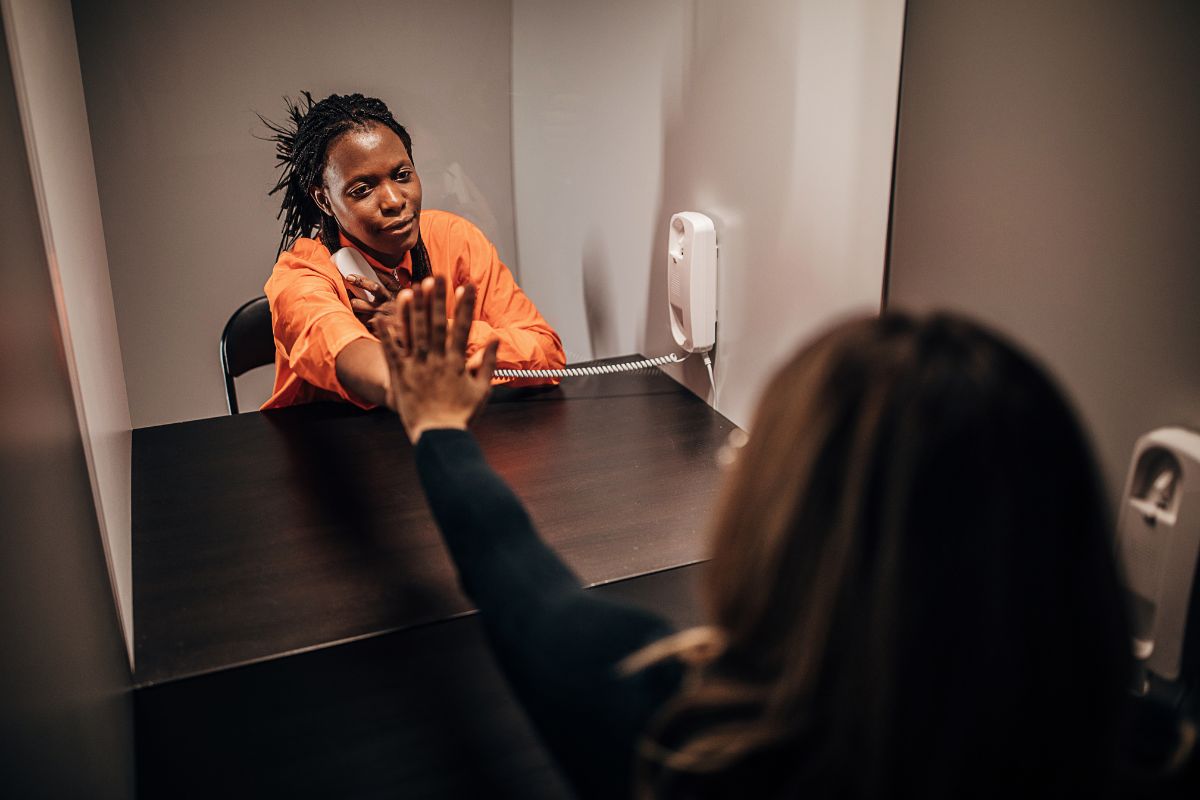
[{"x1": 647, "y1": 314, "x2": 1129, "y2": 798}]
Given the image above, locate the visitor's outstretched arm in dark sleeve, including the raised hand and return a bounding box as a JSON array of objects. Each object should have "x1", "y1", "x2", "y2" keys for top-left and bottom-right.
[{"x1": 379, "y1": 281, "x2": 679, "y2": 798}]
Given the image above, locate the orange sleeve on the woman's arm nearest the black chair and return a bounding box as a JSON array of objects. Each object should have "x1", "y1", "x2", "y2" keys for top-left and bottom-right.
[{"x1": 264, "y1": 239, "x2": 378, "y2": 408}]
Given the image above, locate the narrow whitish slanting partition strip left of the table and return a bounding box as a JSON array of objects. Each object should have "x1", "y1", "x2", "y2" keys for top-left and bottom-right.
[{"x1": 2, "y1": 0, "x2": 133, "y2": 663}]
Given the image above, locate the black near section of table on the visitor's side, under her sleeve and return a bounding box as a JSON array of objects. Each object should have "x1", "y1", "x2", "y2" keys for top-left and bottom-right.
[{"x1": 133, "y1": 564, "x2": 706, "y2": 800}]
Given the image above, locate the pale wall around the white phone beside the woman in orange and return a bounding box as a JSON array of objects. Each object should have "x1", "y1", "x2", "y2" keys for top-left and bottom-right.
[{"x1": 512, "y1": 0, "x2": 904, "y2": 425}]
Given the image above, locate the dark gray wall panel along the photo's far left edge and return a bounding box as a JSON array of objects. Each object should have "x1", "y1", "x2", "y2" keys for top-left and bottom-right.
[{"x1": 0, "y1": 9, "x2": 133, "y2": 798}]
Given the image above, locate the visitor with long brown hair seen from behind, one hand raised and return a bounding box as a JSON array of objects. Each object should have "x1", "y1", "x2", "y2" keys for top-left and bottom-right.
[{"x1": 380, "y1": 279, "x2": 1132, "y2": 799}]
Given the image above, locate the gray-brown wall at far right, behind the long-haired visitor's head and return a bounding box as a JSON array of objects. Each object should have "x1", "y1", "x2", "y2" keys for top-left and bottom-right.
[{"x1": 889, "y1": 0, "x2": 1200, "y2": 501}]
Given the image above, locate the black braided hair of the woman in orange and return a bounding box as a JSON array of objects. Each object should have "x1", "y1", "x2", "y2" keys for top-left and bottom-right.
[{"x1": 258, "y1": 91, "x2": 432, "y2": 282}]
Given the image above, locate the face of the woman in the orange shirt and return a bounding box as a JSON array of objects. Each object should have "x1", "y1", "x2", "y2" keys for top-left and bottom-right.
[{"x1": 312, "y1": 125, "x2": 421, "y2": 266}]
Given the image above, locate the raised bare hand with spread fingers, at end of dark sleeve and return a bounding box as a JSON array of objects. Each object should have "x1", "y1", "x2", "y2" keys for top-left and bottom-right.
[{"x1": 374, "y1": 277, "x2": 499, "y2": 444}]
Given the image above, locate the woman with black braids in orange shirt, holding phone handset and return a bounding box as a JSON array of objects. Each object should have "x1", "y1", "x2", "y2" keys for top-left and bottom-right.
[{"x1": 263, "y1": 92, "x2": 565, "y2": 409}]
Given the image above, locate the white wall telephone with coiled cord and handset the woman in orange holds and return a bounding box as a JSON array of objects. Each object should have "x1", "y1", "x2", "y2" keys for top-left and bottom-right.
[{"x1": 334, "y1": 211, "x2": 716, "y2": 381}]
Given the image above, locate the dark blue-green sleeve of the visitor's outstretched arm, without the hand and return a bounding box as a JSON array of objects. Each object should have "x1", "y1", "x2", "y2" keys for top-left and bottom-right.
[{"x1": 416, "y1": 431, "x2": 680, "y2": 798}]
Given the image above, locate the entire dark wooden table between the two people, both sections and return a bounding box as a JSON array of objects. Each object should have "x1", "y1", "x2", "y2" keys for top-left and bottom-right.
[{"x1": 133, "y1": 371, "x2": 733, "y2": 798}]
